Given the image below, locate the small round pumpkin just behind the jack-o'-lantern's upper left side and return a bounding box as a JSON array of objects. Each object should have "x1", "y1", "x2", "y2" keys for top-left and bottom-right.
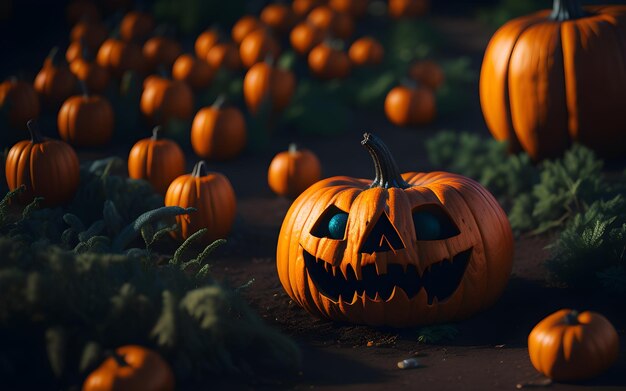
[{"x1": 267, "y1": 144, "x2": 322, "y2": 198}]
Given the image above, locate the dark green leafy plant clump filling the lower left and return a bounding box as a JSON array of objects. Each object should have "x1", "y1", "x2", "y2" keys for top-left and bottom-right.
[{"x1": 0, "y1": 160, "x2": 300, "y2": 388}]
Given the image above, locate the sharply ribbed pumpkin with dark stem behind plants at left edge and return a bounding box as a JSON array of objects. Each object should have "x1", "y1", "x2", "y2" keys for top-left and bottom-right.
[{"x1": 5, "y1": 120, "x2": 80, "y2": 206}]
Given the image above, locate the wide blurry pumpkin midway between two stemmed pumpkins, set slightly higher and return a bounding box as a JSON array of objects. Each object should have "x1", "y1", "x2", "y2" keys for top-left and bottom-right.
[{"x1": 139, "y1": 75, "x2": 193, "y2": 123}]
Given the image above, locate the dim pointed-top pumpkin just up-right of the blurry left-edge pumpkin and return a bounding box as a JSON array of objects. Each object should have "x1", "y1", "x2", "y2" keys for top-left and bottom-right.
[{"x1": 33, "y1": 47, "x2": 76, "y2": 104}]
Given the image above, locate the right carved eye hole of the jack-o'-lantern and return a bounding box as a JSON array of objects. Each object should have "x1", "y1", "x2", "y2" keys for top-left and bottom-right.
[{"x1": 413, "y1": 204, "x2": 461, "y2": 240}]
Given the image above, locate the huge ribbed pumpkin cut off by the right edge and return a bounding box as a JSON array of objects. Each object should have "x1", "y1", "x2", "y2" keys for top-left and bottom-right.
[{"x1": 480, "y1": 1, "x2": 626, "y2": 160}]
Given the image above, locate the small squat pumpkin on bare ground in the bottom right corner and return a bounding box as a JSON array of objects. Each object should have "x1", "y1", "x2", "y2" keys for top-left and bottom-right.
[{"x1": 528, "y1": 309, "x2": 619, "y2": 381}]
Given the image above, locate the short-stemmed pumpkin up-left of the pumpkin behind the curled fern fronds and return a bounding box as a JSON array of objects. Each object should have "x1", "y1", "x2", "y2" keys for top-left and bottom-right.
[{"x1": 128, "y1": 126, "x2": 185, "y2": 195}]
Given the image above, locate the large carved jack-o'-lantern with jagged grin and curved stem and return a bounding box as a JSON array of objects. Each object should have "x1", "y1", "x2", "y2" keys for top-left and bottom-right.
[{"x1": 276, "y1": 134, "x2": 513, "y2": 327}]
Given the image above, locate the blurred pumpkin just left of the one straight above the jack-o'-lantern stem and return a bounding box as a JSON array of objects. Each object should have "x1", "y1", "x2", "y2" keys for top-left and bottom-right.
[{"x1": 308, "y1": 42, "x2": 352, "y2": 80}]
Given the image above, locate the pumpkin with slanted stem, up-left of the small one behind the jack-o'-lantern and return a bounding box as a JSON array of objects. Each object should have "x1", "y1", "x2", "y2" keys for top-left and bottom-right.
[{"x1": 191, "y1": 97, "x2": 246, "y2": 160}]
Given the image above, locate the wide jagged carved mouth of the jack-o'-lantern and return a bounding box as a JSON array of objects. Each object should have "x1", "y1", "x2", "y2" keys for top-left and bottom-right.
[{"x1": 302, "y1": 248, "x2": 472, "y2": 304}]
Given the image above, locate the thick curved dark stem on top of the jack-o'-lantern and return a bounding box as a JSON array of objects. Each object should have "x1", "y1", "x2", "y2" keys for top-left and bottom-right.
[{"x1": 361, "y1": 133, "x2": 411, "y2": 189}]
